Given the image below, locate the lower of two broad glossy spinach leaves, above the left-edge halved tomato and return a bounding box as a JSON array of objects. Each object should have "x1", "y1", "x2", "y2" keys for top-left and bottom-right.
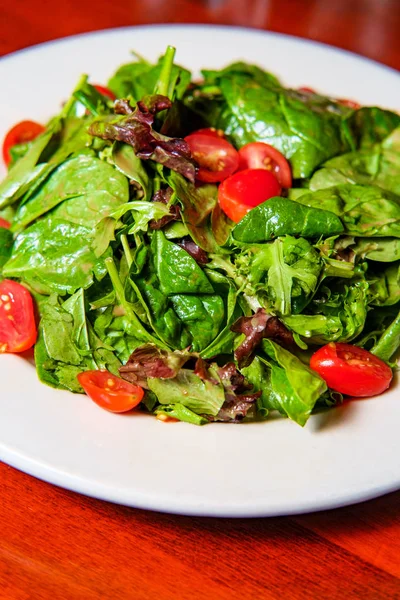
[{"x1": 3, "y1": 217, "x2": 110, "y2": 295}]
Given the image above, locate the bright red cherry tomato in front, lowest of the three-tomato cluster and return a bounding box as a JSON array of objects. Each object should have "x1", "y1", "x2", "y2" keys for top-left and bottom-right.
[{"x1": 218, "y1": 169, "x2": 282, "y2": 223}]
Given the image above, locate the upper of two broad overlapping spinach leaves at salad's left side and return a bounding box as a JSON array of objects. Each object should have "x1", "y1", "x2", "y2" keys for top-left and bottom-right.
[{"x1": 13, "y1": 154, "x2": 129, "y2": 231}]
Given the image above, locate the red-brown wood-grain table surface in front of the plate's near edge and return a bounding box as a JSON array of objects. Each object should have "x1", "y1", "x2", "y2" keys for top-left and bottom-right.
[{"x1": 0, "y1": 465, "x2": 400, "y2": 600}]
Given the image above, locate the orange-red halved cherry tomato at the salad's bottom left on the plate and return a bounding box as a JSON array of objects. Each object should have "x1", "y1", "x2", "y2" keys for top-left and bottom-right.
[{"x1": 78, "y1": 370, "x2": 144, "y2": 412}]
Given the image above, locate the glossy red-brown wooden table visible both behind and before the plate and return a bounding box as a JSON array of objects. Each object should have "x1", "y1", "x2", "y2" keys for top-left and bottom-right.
[{"x1": 0, "y1": 0, "x2": 400, "y2": 600}]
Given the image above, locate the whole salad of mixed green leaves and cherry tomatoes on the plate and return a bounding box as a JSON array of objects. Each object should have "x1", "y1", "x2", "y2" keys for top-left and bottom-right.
[{"x1": 0, "y1": 47, "x2": 400, "y2": 426}]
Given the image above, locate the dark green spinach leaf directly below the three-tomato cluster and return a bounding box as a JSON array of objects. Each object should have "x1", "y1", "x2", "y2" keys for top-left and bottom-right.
[{"x1": 232, "y1": 194, "x2": 344, "y2": 244}]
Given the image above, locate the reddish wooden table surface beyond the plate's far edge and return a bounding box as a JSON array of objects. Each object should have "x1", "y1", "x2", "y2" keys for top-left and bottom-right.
[{"x1": 0, "y1": 0, "x2": 400, "y2": 69}]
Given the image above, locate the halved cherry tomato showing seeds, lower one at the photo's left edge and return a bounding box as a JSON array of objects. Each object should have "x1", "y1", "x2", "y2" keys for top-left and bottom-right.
[{"x1": 0, "y1": 279, "x2": 37, "y2": 353}]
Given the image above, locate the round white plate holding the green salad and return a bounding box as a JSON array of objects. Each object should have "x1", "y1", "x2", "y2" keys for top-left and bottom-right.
[{"x1": 0, "y1": 26, "x2": 400, "y2": 516}]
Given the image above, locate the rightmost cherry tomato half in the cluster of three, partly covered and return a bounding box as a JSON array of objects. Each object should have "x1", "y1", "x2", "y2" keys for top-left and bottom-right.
[{"x1": 239, "y1": 142, "x2": 292, "y2": 188}]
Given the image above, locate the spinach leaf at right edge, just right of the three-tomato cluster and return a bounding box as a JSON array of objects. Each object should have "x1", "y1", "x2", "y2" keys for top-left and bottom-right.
[{"x1": 292, "y1": 184, "x2": 400, "y2": 237}]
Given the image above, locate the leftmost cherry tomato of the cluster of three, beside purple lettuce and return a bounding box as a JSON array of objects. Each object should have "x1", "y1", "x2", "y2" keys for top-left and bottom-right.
[{"x1": 185, "y1": 132, "x2": 239, "y2": 183}]
